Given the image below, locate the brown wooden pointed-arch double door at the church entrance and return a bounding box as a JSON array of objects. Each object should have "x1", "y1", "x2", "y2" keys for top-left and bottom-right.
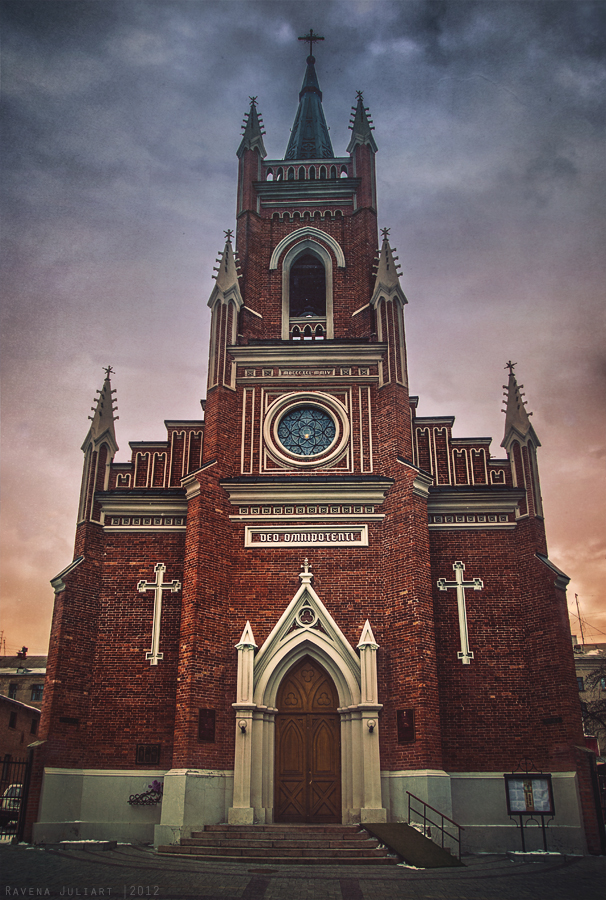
[{"x1": 274, "y1": 657, "x2": 341, "y2": 823}]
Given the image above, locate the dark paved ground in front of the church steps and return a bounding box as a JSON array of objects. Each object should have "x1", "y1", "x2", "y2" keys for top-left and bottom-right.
[{"x1": 0, "y1": 844, "x2": 606, "y2": 900}]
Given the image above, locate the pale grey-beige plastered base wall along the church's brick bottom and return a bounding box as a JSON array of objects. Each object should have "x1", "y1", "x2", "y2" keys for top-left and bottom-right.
[{"x1": 33, "y1": 769, "x2": 587, "y2": 855}]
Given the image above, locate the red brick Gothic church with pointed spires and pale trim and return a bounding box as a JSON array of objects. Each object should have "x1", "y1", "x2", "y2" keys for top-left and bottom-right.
[{"x1": 34, "y1": 45, "x2": 595, "y2": 853}]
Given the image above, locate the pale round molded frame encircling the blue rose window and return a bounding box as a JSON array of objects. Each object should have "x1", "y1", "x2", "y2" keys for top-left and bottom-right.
[{"x1": 263, "y1": 391, "x2": 350, "y2": 469}]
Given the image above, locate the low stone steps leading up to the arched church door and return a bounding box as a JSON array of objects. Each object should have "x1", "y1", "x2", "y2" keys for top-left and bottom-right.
[{"x1": 158, "y1": 825, "x2": 400, "y2": 866}]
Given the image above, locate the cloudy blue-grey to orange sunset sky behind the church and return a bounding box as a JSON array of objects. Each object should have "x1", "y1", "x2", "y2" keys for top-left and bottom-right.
[{"x1": 1, "y1": 0, "x2": 606, "y2": 653}]
